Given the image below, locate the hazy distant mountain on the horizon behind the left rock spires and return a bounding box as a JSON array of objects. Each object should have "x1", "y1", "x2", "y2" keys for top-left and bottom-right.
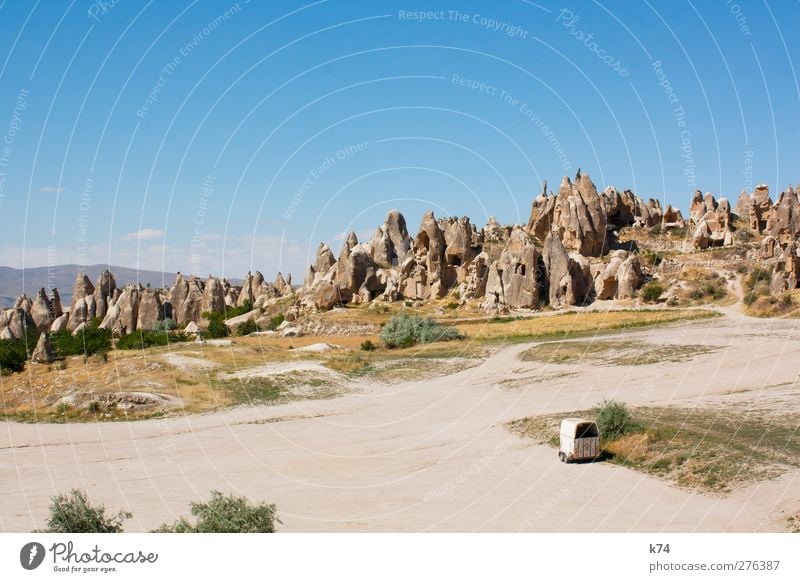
[{"x1": 0, "y1": 265, "x2": 175, "y2": 307}]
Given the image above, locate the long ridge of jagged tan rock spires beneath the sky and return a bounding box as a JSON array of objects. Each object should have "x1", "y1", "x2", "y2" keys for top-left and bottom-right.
[{"x1": 0, "y1": 171, "x2": 800, "y2": 339}]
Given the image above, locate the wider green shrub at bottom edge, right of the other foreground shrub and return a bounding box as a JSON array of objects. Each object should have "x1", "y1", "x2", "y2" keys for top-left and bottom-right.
[{"x1": 154, "y1": 491, "x2": 281, "y2": 533}]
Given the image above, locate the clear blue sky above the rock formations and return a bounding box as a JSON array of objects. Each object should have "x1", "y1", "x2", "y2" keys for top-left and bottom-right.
[{"x1": 0, "y1": 0, "x2": 800, "y2": 281}]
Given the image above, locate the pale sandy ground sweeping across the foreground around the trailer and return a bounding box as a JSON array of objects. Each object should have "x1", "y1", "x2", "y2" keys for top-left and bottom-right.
[{"x1": 0, "y1": 309, "x2": 800, "y2": 532}]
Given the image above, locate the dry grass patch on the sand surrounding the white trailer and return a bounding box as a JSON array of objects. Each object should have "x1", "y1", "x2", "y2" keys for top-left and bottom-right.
[{"x1": 507, "y1": 404, "x2": 800, "y2": 494}]
